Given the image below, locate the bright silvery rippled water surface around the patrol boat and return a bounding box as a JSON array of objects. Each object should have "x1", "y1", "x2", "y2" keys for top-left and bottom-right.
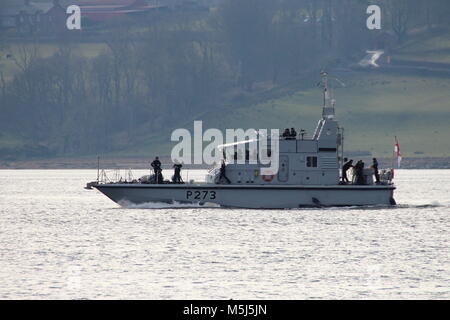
[{"x1": 0, "y1": 170, "x2": 450, "y2": 299}]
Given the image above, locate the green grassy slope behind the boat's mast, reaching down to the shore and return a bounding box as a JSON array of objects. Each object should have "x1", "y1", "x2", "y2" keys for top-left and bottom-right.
[{"x1": 125, "y1": 72, "x2": 450, "y2": 158}]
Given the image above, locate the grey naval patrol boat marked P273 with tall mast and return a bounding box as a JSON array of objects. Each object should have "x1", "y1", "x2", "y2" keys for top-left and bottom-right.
[{"x1": 87, "y1": 72, "x2": 396, "y2": 209}]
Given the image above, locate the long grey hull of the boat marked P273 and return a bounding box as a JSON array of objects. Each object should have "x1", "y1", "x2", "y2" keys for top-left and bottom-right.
[{"x1": 93, "y1": 184, "x2": 395, "y2": 209}]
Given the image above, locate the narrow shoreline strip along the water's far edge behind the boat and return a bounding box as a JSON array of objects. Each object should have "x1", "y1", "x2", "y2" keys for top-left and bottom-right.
[{"x1": 0, "y1": 156, "x2": 450, "y2": 170}]
